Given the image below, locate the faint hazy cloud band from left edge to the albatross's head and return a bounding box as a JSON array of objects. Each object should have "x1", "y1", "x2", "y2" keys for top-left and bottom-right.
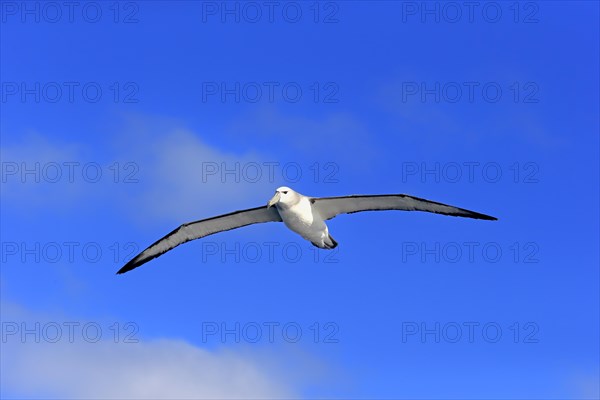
[{"x1": 1, "y1": 120, "x2": 282, "y2": 224}]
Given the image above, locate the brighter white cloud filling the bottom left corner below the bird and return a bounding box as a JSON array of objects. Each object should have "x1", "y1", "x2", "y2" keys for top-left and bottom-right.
[{"x1": 0, "y1": 302, "x2": 306, "y2": 399}]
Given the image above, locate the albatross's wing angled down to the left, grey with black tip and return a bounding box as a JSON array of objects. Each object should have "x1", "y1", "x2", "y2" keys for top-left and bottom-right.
[{"x1": 117, "y1": 206, "x2": 281, "y2": 274}]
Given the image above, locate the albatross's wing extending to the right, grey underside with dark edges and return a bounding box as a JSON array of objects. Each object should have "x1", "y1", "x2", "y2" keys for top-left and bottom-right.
[{"x1": 311, "y1": 194, "x2": 497, "y2": 220}]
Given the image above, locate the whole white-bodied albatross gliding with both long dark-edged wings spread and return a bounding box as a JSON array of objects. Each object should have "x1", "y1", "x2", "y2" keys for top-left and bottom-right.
[{"x1": 117, "y1": 186, "x2": 497, "y2": 274}]
